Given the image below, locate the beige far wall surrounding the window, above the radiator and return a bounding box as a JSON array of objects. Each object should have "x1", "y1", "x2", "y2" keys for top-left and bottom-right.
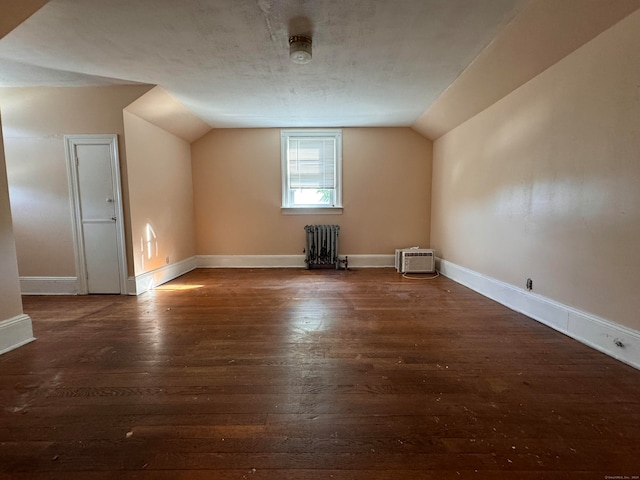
[{"x1": 191, "y1": 128, "x2": 432, "y2": 255}]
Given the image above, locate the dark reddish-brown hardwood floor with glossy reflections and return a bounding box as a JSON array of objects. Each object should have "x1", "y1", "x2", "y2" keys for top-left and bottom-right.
[{"x1": 0, "y1": 269, "x2": 640, "y2": 480}]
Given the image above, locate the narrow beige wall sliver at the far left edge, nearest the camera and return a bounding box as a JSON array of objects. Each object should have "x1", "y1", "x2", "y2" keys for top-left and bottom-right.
[{"x1": 0, "y1": 114, "x2": 22, "y2": 322}]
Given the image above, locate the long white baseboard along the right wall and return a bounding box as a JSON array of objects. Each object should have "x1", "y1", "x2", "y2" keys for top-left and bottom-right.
[{"x1": 438, "y1": 259, "x2": 640, "y2": 369}]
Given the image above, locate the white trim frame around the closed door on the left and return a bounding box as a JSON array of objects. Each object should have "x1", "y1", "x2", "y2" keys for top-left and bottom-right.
[{"x1": 64, "y1": 134, "x2": 127, "y2": 295}]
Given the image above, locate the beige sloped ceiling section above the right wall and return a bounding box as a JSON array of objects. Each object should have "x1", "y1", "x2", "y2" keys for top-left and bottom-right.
[{"x1": 411, "y1": 0, "x2": 640, "y2": 140}]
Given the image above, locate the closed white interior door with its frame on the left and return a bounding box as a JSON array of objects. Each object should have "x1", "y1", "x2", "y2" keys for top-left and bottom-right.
[{"x1": 66, "y1": 135, "x2": 126, "y2": 294}]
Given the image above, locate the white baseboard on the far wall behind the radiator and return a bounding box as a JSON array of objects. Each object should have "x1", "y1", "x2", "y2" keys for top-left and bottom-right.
[{"x1": 196, "y1": 255, "x2": 395, "y2": 268}]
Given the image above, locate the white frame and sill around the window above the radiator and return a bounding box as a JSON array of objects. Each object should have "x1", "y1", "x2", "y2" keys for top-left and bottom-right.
[{"x1": 280, "y1": 129, "x2": 342, "y2": 214}]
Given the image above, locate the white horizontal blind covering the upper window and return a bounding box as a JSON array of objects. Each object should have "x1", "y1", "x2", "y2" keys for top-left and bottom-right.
[{"x1": 288, "y1": 137, "x2": 336, "y2": 190}]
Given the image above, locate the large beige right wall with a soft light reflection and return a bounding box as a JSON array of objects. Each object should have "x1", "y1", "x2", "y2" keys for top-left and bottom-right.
[{"x1": 432, "y1": 12, "x2": 640, "y2": 329}]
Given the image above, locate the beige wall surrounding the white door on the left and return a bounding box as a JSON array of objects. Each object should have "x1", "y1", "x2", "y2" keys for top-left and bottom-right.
[{"x1": 0, "y1": 86, "x2": 150, "y2": 277}]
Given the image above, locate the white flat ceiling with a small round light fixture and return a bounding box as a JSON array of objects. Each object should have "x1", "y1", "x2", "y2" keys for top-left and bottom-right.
[{"x1": 0, "y1": 0, "x2": 529, "y2": 127}]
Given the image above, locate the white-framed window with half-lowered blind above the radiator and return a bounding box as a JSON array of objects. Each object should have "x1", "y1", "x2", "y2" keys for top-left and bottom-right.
[{"x1": 282, "y1": 130, "x2": 342, "y2": 209}]
